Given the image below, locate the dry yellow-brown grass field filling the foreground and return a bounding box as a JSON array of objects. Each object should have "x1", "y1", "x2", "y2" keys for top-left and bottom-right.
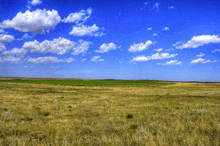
[{"x1": 0, "y1": 78, "x2": 220, "y2": 146}]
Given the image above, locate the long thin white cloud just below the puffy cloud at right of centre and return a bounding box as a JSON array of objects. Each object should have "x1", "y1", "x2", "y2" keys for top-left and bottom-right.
[{"x1": 132, "y1": 53, "x2": 178, "y2": 62}]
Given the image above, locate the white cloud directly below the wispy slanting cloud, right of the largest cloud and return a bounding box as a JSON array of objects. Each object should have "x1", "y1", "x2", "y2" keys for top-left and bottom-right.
[{"x1": 69, "y1": 24, "x2": 103, "y2": 37}]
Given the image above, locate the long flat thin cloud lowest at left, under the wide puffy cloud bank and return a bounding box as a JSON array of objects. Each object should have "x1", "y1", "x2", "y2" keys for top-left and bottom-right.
[{"x1": 27, "y1": 56, "x2": 75, "y2": 64}]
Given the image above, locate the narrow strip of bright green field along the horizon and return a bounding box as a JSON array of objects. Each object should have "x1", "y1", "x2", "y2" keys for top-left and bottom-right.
[{"x1": 0, "y1": 78, "x2": 174, "y2": 86}]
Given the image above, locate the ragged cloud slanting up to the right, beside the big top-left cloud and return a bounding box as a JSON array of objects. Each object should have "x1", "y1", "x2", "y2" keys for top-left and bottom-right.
[{"x1": 62, "y1": 8, "x2": 92, "y2": 24}]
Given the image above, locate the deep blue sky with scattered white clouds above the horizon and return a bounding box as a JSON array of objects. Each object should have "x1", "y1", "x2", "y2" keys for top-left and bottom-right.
[{"x1": 0, "y1": 0, "x2": 220, "y2": 82}]
